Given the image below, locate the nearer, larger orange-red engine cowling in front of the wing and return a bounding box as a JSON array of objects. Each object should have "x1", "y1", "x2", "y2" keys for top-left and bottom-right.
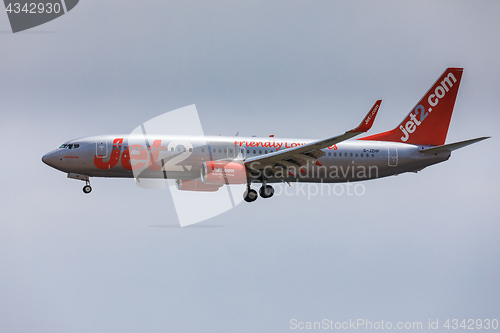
[{"x1": 201, "y1": 161, "x2": 247, "y2": 185}]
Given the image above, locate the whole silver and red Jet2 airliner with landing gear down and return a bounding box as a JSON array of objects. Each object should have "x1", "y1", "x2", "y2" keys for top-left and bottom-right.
[{"x1": 42, "y1": 67, "x2": 489, "y2": 202}]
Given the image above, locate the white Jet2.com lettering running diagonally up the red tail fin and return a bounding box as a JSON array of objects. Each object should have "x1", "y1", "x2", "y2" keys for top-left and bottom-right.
[{"x1": 399, "y1": 73, "x2": 457, "y2": 142}]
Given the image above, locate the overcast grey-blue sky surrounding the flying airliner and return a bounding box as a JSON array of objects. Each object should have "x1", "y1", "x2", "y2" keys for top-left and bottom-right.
[{"x1": 0, "y1": 0, "x2": 500, "y2": 333}]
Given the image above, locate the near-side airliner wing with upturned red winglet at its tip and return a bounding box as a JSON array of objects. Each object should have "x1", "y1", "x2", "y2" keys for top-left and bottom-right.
[{"x1": 245, "y1": 100, "x2": 382, "y2": 171}]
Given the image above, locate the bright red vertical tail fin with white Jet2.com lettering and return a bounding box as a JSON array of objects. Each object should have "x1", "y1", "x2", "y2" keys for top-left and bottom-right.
[{"x1": 359, "y1": 67, "x2": 463, "y2": 146}]
